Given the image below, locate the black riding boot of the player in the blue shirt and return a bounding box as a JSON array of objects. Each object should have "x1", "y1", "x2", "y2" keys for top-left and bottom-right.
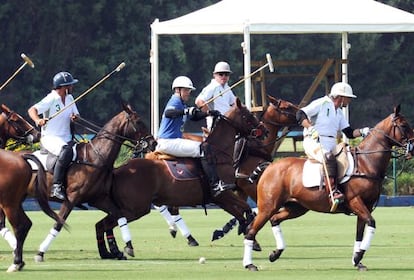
[{"x1": 201, "y1": 142, "x2": 236, "y2": 197}]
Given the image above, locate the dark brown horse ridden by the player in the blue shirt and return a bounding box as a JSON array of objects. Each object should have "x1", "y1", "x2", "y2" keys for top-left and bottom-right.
[{"x1": 92, "y1": 99, "x2": 261, "y2": 258}]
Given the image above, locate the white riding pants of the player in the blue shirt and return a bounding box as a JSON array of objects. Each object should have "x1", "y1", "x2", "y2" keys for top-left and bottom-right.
[{"x1": 155, "y1": 138, "x2": 202, "y2": 158}]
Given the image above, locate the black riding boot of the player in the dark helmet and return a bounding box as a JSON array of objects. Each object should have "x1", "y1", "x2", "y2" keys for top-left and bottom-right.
[{"x1": 50, "y1": 145, "x2": 73, "y2": 200}]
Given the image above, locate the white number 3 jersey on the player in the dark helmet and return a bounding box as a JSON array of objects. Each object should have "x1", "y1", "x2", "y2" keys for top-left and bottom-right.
[{"x1": 34, "y1": 90, "x2": 79, "y2": 143}]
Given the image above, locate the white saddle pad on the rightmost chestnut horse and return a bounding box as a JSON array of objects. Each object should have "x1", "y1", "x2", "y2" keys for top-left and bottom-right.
[{"x1": 302, "y1": 147, "x2": 355, "y2": 188}]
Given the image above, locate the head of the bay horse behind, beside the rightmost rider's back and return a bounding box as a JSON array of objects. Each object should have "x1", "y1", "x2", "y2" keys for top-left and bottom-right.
[{"x1": 261, "y1": 95, "x2": 299, "y2": 127}]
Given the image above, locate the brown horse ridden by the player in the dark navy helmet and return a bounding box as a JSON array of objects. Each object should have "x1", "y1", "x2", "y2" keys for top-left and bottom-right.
[{"x1": 29, "y1": 104, "x2": 155, "y2": 261}]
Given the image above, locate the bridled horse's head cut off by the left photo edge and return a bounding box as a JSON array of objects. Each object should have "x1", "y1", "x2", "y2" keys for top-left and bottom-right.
[{"x1": 0, "y1": 104, "x2": 40, "y2": 147}]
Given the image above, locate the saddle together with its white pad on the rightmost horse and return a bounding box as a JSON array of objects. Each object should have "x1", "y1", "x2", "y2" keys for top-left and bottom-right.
[{"x1": 302, "y1": 143, "x2": 355, "y2": 187}]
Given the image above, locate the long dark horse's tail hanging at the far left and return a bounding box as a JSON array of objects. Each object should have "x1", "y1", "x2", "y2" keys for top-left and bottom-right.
[{"x1": 22, "y1": 154, "x2": 65, "y2": 225}]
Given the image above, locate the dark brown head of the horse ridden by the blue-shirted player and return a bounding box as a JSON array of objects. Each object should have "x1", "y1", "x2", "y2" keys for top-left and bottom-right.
[{"x1": 224, "y1": 98, "x2": 267, "y2": 138}]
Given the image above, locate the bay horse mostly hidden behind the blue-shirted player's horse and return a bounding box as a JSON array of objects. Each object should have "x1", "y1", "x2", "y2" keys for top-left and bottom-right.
[{"x1": 212, "y1": 95, "x2": 299, "y2": 243}]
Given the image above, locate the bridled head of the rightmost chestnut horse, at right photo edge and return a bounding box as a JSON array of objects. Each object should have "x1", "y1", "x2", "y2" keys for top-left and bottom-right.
[{"x1": 367, "y1": 105, "x2": 414, "y2": 157}]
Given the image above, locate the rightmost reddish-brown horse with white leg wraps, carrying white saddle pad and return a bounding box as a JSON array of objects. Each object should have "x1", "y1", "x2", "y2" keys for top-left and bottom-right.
[{"x1": 243, "y1": 106, "x2": 414, "y2": 271}]
